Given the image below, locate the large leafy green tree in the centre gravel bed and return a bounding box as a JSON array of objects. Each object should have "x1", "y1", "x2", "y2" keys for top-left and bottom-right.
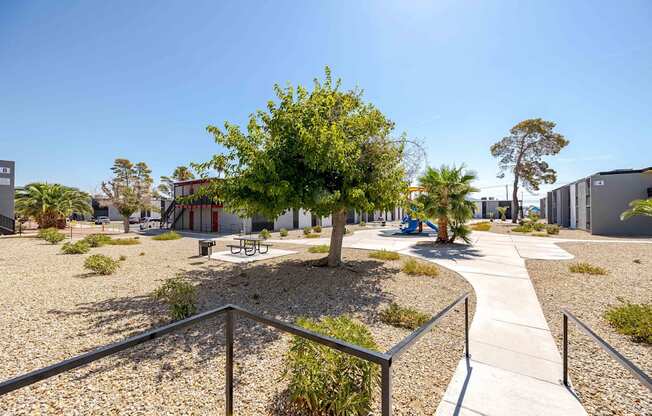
[{"x1": 196, "y1": 68, "x2": 406, "y2": 267}]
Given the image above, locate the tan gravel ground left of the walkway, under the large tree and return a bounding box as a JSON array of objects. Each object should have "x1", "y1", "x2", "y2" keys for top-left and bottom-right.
[{"x1": 0, "y1": 232, "x2": 471, "y2": 415}]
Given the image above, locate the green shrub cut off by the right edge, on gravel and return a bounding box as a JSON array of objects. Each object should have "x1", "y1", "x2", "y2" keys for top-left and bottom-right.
[{"x1": 605, "y1": 303, "x2": 652, "y2": 344}]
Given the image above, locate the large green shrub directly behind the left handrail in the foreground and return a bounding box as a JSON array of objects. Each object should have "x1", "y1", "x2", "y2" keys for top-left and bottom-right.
[{"x1": 283, "y1": 316, "x2": 380, "y2": 416}]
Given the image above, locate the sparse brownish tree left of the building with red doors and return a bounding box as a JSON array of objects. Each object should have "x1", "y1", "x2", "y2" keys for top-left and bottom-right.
[{"x1": 102, "y1": 159, "x2": 153, "y2": 233}]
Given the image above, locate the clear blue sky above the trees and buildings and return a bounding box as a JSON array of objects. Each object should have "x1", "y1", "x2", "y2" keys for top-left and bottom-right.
[{"x1": 0, "y1": 0, "x2": 652, "y2": 200}]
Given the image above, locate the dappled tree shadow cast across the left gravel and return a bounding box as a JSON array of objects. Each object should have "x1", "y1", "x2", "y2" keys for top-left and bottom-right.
[{"x1": 50, "y1": 260, "x2": 396, "y2": 382}]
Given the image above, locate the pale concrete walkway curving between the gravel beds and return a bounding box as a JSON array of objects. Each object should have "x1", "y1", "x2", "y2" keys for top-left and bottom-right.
[{"x1": 278, "y1": 229, "x2": 586, "y2": 416}]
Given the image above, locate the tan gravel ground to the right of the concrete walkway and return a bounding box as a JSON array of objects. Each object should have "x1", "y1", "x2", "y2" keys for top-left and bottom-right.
[{"x1": 527, "y1": 243, "x2": 652, "y2": 415}]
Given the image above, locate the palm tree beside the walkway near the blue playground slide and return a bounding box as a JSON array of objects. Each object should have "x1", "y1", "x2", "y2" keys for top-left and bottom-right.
[{"x1": 419, "y1": 165, "x2": 478, "y2": 243}]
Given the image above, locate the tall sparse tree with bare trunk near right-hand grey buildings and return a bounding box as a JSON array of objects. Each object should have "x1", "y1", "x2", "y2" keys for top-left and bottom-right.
[{"x1": 490, "y1": 118, "x2": 569, "y2": 223}]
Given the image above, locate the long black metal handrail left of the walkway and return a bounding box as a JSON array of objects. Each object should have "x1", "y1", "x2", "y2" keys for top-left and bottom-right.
[{"x1": 0, "y1": 292, "x2": 469, "y2": 416}]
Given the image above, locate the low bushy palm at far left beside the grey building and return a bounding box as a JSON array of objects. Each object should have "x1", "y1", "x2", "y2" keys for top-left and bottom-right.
[{"x1": 16, "y1": 182, "x2": 93, "y2": 228}]
